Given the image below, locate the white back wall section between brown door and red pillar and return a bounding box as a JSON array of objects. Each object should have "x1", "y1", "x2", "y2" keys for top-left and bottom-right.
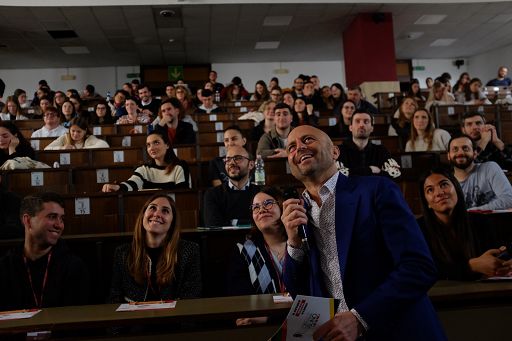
[{"x1": 212, "y1": 60, "x2": 345, "y2": 92}]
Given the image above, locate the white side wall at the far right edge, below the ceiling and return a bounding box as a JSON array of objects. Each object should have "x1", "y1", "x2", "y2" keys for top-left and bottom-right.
[{"x1": 468, "y1": 45, "x2": 512, "y2": 84}]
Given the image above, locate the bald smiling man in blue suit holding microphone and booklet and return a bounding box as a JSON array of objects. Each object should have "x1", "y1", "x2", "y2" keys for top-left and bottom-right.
[{"x1": 281, "y1": 126, "x2": 446, "y2": 341}]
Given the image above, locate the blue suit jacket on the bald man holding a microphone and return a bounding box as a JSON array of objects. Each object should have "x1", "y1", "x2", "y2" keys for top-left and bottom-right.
[{"x1": 284, "y1": 174, "x2": 446, "y2": 340}]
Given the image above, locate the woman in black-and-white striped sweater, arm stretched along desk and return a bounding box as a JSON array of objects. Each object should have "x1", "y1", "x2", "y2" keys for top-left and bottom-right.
[{"x1": 102, "y1": 131, "x2": 190, "y2": 192}]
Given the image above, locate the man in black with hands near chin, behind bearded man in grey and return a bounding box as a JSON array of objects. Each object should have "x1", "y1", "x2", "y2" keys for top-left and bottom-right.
[{"x1": 461, "y1": 112, "x2": 511, "y2": 169}]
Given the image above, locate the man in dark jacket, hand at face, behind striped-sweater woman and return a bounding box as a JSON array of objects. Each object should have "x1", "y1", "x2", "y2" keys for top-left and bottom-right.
[{"x1": 152, "y1": 98, "x2": 196, "y2": 145}]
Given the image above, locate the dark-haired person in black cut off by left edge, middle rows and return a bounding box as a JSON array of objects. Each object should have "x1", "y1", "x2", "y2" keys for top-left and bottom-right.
[{"x1": 0, "y1": 121, "x2": 35, "y2": 166}]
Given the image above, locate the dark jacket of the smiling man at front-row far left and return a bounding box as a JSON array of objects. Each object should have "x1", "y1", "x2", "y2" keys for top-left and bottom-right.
[{"x1": 0, "y1": 239, "x2": 90, "y2": 310}]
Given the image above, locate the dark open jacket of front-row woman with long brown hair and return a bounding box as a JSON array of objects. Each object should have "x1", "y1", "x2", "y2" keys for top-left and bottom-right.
[{"x1": 108, "y1": 240, "x2": 202, "y2": 303}]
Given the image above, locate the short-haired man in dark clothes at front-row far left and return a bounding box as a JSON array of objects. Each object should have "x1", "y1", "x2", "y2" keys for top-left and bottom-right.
[{"x1": 0, "y1": 193, "x2": 90, "y2": 311}]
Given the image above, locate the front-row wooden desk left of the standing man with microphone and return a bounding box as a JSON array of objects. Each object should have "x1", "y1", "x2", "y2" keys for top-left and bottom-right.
[{"x1": 0, "y1": 295, "x2": 291, "y2": 340}]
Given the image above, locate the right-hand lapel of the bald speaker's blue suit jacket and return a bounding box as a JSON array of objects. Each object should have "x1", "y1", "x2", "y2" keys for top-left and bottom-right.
[{"x1": 335, "y1": 174, "x2": 357, "y2": 280}]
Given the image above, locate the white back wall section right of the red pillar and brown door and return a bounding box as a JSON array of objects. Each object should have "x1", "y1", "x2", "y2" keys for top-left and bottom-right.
[{"x1": 412, "y1": 59, "x2": 468, "y2": 89}]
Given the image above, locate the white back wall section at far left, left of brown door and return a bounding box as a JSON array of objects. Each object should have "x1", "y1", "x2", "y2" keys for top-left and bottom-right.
[{"x1": 0, "y1": 66, "x2": 139, "y2": 99}]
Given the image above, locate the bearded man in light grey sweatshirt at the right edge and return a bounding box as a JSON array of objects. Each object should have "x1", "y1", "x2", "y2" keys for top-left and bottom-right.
[{"x1": 448, "y1": 135, "x2": 512, "y2": 210}]
